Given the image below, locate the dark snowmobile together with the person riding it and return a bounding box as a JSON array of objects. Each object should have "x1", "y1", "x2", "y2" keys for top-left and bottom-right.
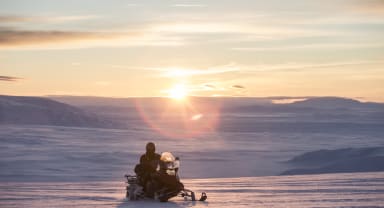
[{"x1": 125, "y1": 145, "x2": 207, "y2": 202}]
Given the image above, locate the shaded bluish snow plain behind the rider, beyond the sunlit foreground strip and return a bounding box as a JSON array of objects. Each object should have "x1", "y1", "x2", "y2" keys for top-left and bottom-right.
[{"x1": 0, "y1": 125, "x2": 384, "y2": 182}]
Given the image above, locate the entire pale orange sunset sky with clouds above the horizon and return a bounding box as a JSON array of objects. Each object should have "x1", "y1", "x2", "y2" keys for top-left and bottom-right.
[{"x1": 0, "y1": 0, "x2": 384, "y2": 102}]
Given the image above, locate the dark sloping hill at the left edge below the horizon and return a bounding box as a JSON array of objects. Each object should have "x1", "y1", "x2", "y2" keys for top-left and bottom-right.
[{"x1": 0, "y1": 95, "x2": 116, "y2": 128}]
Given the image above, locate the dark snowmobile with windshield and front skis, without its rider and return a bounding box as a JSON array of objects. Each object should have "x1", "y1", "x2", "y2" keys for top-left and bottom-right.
[{"x1": 124, "y1": 152, "x2": 207, "y2": 202}]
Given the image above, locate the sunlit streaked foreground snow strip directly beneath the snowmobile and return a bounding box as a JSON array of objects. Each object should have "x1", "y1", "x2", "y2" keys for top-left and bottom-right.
[{"x1": 0, "y1": 173, "x2": 384, "y2": 208}]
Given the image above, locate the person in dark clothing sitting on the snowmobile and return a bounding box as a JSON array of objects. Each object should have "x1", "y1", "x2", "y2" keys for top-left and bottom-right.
[{"x1": 135, "y1": 142, "x2": 160, "y2": 197}]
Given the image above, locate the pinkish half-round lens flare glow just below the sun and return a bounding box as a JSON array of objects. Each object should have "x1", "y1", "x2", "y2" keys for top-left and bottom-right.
[{"x1": 135, "y1": 98, "x2": 220, "y2": 139}]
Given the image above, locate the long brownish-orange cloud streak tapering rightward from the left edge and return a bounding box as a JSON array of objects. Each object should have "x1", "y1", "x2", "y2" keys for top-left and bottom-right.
[{"x1": 0, "y1": 27, "x2": 173, "y2": 49}]
